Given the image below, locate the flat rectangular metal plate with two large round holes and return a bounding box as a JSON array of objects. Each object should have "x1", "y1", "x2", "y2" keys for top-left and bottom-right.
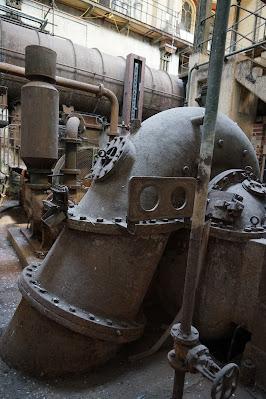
[{"x1": 128, "y1": 176, "x2": 197, "y2": 223}]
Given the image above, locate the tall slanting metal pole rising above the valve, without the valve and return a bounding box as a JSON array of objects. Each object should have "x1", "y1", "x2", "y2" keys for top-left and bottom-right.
[{"x1": 181, "y1": 0, "x2": 231, "y2": 335}]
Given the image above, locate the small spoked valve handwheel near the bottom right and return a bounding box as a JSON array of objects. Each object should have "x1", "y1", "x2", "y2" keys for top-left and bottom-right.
[{"x1": 211, "y1": 363, "x2": 239, "y2": 399}]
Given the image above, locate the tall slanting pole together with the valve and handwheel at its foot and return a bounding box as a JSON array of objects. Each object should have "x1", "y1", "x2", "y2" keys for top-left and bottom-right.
[{"x1": 169, "y1": 0, "x2": 238, "y2": 399}]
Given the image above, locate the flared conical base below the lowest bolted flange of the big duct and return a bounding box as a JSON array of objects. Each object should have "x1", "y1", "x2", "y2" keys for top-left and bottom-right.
[{"x1": 1, "y1": 299, "x2": 119, "y2": 377}]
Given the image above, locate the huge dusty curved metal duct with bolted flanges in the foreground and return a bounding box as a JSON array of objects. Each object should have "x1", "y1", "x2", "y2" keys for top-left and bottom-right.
[{"x1": 1, "y1": 108, "x2": 258, "y2": 375}]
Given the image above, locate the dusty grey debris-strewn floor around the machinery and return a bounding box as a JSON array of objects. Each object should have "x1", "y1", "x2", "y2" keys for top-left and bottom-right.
[{"x1": 0, "y1": 209, "x2": 266, "y2": 399}]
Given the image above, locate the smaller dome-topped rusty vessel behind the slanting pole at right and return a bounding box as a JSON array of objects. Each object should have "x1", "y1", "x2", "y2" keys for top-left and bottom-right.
[{"x1": 158, "y1": 169, "x2": 266, "y2": 339}]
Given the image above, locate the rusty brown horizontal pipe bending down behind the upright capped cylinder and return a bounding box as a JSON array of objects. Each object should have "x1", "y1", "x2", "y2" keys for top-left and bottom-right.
[{"x1": 0, "y1": 62, "x2": 119, "y2": 136}]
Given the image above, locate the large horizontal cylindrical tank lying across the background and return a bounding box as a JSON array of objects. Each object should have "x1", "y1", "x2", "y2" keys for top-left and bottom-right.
[{"x1": 0, "y1": 20, "x2": 184, "y2": 119}]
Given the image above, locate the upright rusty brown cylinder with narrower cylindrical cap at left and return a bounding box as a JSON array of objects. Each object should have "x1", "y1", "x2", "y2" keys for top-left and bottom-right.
[{"x1": 21, "y1": 46, "x2": 59, "y2": 170}]
